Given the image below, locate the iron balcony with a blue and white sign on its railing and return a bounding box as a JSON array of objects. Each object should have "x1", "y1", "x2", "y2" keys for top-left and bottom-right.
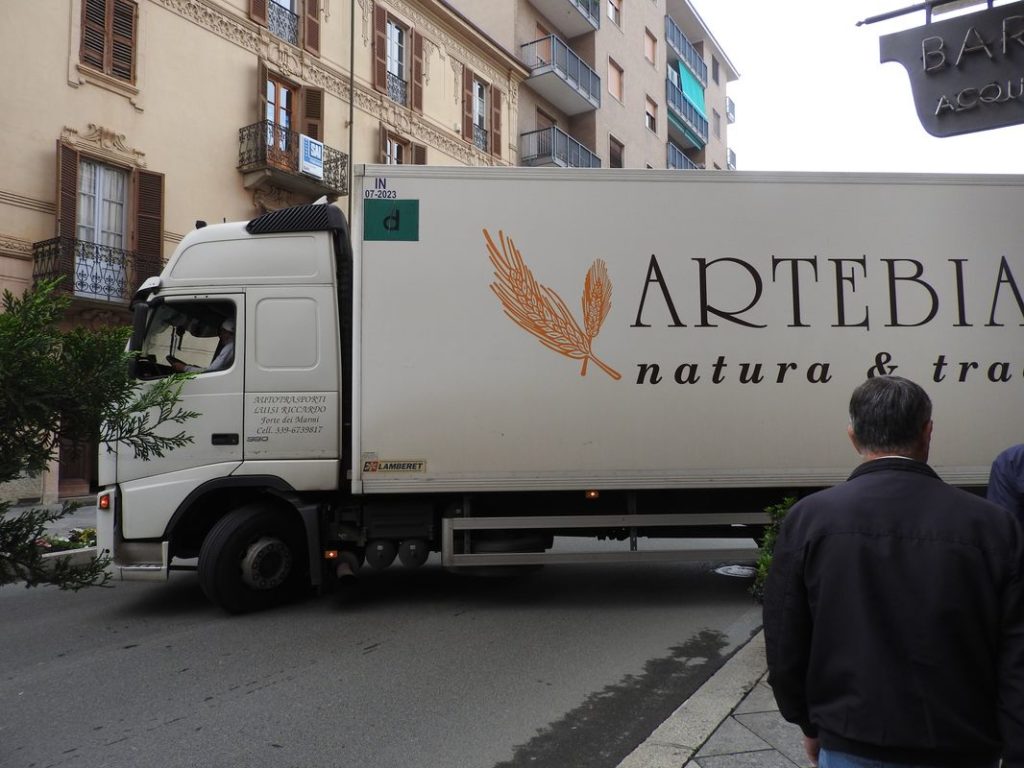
[{"x1": 239, "y1": 120, "x2": 348, "y2": 198}]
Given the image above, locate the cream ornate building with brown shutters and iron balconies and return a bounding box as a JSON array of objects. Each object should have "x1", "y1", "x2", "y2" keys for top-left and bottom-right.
[{"x1": 0, "y1": 0, "x2": 529, "y2": 501}]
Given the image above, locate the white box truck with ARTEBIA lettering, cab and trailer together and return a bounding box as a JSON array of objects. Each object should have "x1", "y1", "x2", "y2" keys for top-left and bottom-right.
[{"x1": 98, "y1": 166, "x2": 1024, "y2": 611}]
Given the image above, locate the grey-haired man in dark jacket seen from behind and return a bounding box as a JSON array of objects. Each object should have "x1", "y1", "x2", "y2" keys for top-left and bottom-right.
[{"x1": 764, "y1": 376, "x2": 1024, "y2": 768}]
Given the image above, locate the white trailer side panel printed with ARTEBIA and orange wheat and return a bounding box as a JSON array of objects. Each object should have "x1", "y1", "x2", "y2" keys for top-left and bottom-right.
[{"x1": 352, "y1": 166, "x2": 1024, "y2": 494}]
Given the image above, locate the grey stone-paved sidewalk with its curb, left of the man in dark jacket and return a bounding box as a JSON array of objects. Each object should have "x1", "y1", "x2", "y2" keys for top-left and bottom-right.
[{"x1": 618, "y1": 632, "x2": 810, "y2": 768}]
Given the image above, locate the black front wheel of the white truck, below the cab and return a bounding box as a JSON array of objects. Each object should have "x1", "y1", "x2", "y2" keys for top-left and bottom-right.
[{"x1": 199, "y1": 504, "x2": 309, "y2": 613}]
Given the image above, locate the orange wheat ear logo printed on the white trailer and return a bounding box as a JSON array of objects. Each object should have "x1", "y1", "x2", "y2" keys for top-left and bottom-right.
[{"x1": 483, "y1": 229, "x2": 623, "y2": 380}]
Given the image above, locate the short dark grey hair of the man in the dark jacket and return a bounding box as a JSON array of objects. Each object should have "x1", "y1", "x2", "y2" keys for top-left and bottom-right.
[{"x1": 850, "y1": 376, "x2": 932, "y2": 453}]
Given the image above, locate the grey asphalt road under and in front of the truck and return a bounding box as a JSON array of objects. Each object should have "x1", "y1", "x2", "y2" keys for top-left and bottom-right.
[{"x1": 0, "y1": 548, "x2": 760, "y2": 768}]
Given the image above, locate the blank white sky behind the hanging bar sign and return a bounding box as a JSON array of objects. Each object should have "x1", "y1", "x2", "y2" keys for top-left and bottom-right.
[{"x1": 691, "y1": 0, "x2": 1024, "y2": 173}]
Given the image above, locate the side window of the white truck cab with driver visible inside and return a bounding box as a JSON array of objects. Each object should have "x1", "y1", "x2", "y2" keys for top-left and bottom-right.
[{"x1": 137, "y1": 301, "x2": 236, "y2": 379}]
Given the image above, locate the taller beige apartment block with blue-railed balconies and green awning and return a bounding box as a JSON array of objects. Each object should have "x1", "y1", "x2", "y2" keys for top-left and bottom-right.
[{"x1": 450, "y1": 0, "x2": 738, "y2": 169}]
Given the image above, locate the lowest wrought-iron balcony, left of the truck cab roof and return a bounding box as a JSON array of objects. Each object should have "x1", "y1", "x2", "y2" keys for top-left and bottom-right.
[{"x1": 32, "y1": 238, "x2": 162, "y2": 305}]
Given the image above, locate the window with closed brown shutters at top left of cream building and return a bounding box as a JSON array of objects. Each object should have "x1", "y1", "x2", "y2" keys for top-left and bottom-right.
[{"x1": 81, "y1": 0, "x2": 138, "y2": 83}]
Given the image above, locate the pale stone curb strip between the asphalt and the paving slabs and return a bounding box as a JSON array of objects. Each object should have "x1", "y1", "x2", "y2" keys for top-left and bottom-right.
[{"x1": 617, "y1": 632, "x2": 767, "y2": 768}]
